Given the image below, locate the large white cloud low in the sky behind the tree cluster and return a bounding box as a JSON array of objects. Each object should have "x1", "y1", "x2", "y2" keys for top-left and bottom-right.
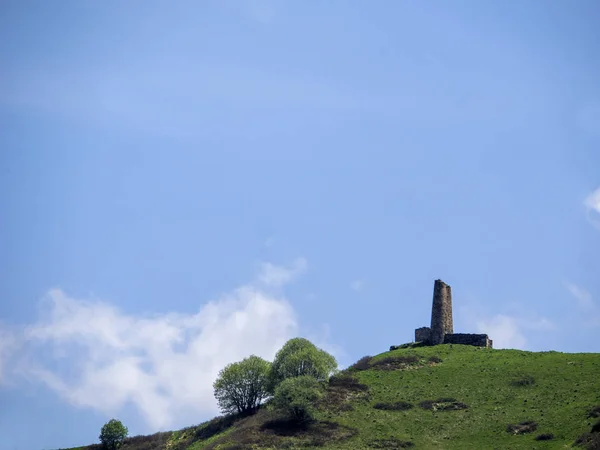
[{"x1": 5, "y1": 259, "x2": 327, "y2": 430}]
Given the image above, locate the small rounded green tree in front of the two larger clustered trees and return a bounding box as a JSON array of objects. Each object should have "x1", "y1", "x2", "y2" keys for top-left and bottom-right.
[{"x1": 272, "y1": 375, "x2": 323, "y2": 422}]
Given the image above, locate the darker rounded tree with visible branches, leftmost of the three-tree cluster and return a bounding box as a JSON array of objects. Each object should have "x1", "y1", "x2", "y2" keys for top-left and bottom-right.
[{"x1": 213, "y1": 355, "x2": 271, "y2": 414}]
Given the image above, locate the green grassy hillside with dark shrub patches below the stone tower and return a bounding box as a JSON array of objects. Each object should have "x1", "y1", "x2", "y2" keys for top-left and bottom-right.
[{"x1": 59, "y1": 345, "x2": 600, "y2": 450}]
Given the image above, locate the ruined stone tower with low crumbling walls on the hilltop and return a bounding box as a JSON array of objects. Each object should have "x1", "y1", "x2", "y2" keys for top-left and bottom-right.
[{"x1": 415, "y1": 280, "x2": 493, "y2": 348}]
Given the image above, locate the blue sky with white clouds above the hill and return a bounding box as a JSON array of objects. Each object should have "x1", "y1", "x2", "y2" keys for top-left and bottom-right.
[{"x1": 0, "y1": 0, "x2": 600, "y2": 450}]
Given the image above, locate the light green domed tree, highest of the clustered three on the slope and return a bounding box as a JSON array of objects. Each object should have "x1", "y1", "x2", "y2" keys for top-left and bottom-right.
[{"x1": 269, "y1": 338, "x2": 337, "y2": 391}]
